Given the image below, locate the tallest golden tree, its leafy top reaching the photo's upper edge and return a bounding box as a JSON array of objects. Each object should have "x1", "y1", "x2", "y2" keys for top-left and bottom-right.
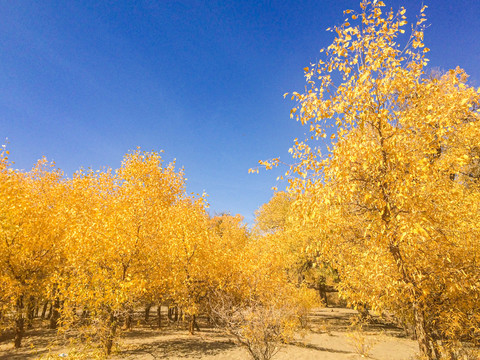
[{"x1": 270, "y1": 0, "x2": 480, "y2": 359}]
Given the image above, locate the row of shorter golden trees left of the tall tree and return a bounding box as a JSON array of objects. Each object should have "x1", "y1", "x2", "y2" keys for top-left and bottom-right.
[{"x1": 0, "y1": 148, "x2": 318, "y2": 359}]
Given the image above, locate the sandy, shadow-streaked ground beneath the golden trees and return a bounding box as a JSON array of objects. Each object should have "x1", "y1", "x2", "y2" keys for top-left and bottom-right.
[{"x1": 0, "y1": 308, "x2": 418, "y2": 360}]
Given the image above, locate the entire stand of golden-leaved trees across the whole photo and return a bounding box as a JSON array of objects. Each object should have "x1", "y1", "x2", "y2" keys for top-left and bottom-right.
[{"x1": 0, "y1": 0, "x2": 480, "y2": 360}]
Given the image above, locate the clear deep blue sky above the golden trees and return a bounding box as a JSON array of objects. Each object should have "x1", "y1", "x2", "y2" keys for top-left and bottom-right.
[{"x1": 0, "y1": 0, "x2": 480, "y2": 223}]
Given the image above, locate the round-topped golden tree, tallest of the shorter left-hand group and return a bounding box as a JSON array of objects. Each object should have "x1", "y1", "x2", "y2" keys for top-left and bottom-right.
[{"x1": 59, "y1": 150, "x2": 189, "y2": 354}]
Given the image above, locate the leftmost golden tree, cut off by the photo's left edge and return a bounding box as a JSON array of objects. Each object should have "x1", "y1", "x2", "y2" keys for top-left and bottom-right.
[{"x1": 0, "y1": 149, "x2": 64, "y2": 347}]
